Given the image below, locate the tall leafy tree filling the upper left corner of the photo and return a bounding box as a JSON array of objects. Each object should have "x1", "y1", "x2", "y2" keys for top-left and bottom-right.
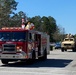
[{"x1": 0, "y1": 0, "x2": 18, "y2": 27}]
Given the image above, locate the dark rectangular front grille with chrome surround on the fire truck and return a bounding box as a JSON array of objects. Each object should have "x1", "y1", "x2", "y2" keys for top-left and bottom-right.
[{"x1": 3, "y1": 44, "x2": 16, "y2": 52}]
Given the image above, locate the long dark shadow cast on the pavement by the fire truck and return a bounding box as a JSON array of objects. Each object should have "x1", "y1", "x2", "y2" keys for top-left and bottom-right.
[{"x1": 1, "y1": 59, "x2": 72, "y2": 68}]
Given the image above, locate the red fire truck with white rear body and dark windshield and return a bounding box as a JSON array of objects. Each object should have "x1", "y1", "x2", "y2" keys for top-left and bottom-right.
[{"x1": 0, "y1": 27, "x2": 49, "y2": 64}]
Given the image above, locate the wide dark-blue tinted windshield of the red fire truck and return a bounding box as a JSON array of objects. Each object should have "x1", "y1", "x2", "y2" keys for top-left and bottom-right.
[{"x1": 0, "y1": 32, "x2": 26, "y2": 41}]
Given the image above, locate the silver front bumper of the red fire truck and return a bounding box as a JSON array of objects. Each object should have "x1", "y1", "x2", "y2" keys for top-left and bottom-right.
[{"x1": 0, "y1": 54, "x2": 27, "y2": 59}]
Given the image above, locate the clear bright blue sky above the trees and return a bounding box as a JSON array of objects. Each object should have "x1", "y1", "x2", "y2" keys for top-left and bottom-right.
[{"x1": 15, "y1": 0, "x2": 76, "y2": 34}]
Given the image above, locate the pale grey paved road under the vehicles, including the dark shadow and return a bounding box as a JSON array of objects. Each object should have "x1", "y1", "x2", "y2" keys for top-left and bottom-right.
[{"x1": 0, "y1": 50, "x2": 76, "y2": 75}]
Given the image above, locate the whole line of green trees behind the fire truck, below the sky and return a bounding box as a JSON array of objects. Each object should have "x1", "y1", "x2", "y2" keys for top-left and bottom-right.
[{"x1": 0, "y1": 0, "x2": 63, "y2": 42}]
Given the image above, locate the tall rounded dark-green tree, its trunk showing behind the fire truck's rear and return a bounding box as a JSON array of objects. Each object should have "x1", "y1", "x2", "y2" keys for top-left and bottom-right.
[{"x1": 42, "y1": 16, "x2": 57, "y2": 42}]
